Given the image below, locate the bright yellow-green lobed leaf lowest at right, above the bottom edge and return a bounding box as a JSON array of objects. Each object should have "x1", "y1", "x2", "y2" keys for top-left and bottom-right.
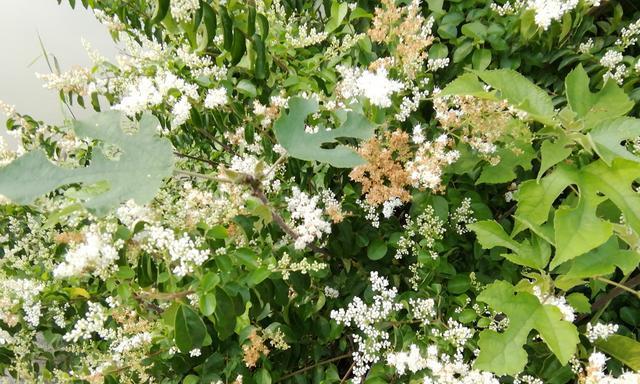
[{"x1": 475, "y1": 281, "x2": 579, "y2": 375}]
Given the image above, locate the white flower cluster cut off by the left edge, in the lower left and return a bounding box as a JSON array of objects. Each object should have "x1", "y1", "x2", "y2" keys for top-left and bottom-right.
[{"x1": 0, "y1": 278, "x2": 45, "y2": 327}]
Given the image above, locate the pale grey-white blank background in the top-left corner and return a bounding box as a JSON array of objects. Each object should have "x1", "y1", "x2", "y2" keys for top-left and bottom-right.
[{"x1": 0, "y1": 0, "x2": 116, "y2": 146}]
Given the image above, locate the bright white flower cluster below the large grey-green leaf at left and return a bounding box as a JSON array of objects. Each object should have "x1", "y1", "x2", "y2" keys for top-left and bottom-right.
[{"x1": 53, "y1": 224, "x2": 124, "y2": 279}]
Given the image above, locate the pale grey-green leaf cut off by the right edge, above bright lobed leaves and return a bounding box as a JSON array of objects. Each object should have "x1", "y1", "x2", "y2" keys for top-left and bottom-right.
[{"x1": 588, "y1": 117, "x2": 640, "y2": 165}]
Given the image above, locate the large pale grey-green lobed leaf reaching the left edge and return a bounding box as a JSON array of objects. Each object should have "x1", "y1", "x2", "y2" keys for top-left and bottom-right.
[{"x1": 0, "y1": 111, "x2": 173, "y2": 215}]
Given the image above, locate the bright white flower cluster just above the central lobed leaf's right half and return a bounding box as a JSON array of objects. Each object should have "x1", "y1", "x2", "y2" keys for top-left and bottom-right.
[{"x1": 336, "y1": 65, "x2": 404, "y2": 108}]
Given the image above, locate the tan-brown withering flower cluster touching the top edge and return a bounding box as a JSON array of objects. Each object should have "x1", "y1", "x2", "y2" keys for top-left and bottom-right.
[{"x1": 368, "y1": 0, "x2": 434, "y2": 79}]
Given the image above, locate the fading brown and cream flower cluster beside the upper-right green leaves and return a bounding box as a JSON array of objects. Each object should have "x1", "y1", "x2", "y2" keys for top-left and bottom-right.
[{"x1": 433, "y1": 96, "x2": 531, "y2": 163}]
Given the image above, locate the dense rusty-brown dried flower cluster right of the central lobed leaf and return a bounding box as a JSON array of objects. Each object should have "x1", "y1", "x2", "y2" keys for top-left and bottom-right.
[{"x1": 349, "y1": 130, "x2": 411, "y2": 206}]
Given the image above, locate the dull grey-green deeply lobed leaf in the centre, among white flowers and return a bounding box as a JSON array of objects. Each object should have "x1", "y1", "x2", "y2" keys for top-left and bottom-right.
[{"x1": 273, "y1": 97, "x2": 373, "y2": 168}]
